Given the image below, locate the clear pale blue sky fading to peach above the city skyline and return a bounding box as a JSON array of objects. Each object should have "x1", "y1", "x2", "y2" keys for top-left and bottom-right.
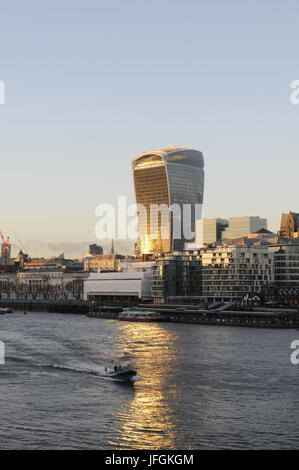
[{"x1": 0, "y1": 0, "x2": 299, "y2": 256}]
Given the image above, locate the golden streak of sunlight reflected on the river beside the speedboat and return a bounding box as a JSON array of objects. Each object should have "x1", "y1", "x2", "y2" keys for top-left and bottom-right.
[{"x1": 109, "y1": 322, "x2": 193, "y2": 449}]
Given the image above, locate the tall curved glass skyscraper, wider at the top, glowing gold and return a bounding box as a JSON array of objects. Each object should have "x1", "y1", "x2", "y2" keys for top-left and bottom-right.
[{"x1": 132, "y1": 147, "x2": 204, "y2": 254}]
